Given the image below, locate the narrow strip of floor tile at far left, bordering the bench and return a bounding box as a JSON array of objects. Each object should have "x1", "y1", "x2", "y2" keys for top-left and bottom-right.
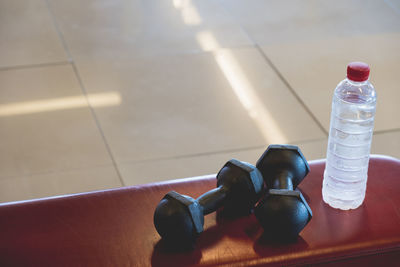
[{"x1": 0, "y1": 165, "x2": 122, "y2": 202}]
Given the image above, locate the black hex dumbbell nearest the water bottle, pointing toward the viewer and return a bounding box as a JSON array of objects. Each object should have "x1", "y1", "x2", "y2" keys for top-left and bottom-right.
[{"x1": 254, "y1": 145, "x2": 312, "y2": 240}]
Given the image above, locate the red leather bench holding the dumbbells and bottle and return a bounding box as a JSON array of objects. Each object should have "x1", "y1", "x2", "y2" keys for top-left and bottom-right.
[{"x1": 0, "y1": 156, "x2": 400, "y2": 266}]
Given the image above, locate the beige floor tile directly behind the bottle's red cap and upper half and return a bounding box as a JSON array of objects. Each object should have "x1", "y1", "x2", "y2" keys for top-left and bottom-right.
[{"x1": 262, "y1": 33, "x2": 400, "y2": 131}]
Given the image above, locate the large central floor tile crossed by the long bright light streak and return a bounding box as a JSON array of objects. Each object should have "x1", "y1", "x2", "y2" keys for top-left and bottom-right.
[{"x1": 77, "y1": 48, "x2": 324, "y2": 162}]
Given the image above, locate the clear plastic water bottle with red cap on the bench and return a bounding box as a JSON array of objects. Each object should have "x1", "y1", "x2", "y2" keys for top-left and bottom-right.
[{"x1": 322, "y1": 62, "x2": 376, "y2": 210}]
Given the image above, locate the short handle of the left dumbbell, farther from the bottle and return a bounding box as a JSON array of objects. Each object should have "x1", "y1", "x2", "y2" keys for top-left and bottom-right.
[{"x1": 196, "y1": 185, "x2": 228, "y2": 215}]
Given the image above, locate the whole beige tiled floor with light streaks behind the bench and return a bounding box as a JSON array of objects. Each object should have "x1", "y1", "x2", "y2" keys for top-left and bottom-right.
[{"x1": 0, "y1": 0, "x2": 400, "y2": 202}]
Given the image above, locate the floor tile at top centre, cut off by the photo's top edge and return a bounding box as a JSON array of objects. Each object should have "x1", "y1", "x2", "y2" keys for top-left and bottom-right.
[{"x1": 50, "y1": 0, "x2": 252, "y2": 59}]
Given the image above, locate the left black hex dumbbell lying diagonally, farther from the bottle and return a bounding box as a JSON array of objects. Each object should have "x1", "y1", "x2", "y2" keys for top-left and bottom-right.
[{"x1": 154, "y1": 159, "x2": 264, "y2": 247}]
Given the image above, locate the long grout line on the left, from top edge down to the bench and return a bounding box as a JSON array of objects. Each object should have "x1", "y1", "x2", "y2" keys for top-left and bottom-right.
[{"x1": 45, "y1": 0, "x2": 126, "y2": 186}]
